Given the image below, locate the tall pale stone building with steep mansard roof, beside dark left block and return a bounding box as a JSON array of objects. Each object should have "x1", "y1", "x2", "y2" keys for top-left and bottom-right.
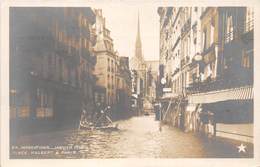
[{"x1": 94, "y1": 9, "x2": 118, "y2": 105}]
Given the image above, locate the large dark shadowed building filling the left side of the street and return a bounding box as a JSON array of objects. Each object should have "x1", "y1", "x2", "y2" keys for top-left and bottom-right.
[{"x1": 10, "y1": 7, "x2": 96, "y2": 134}]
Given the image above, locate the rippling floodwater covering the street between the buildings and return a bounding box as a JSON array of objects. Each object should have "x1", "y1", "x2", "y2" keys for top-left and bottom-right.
[{"x1": 11, "y1": 115, "x2": 253, "y2": 158}]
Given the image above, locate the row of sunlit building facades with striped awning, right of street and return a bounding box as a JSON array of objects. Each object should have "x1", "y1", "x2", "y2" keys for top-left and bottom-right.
[{"x1": 158, "y1": 7, "x2": 254, "y2": 141}]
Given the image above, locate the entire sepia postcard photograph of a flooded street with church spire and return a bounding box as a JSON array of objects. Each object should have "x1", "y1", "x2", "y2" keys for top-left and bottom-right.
[{"x1": 1, "y1": 1, "x2": 258, "y2": 166}]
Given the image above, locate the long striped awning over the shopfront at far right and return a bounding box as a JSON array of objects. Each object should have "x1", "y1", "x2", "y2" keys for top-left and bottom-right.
[{"x1": 188, "y1": 86, "x2": 254, "y2": 104}]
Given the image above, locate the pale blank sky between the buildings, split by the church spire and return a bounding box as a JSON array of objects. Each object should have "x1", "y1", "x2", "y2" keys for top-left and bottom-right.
[{"x1": 102, "y1": 6, "x2": 160, "y2": 60}]
